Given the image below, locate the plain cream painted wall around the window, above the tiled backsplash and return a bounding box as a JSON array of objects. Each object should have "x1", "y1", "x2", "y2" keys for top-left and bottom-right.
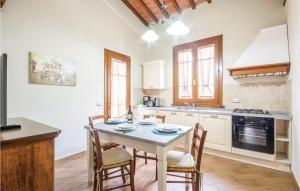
[{"x1": 147, "y1": 0, "x2": 286, "y2": 86}]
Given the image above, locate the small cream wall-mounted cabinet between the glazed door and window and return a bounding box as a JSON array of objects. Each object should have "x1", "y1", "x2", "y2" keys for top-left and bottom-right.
[{"x1": 143, "y1": 60, "x2": 166, "y2": 89}]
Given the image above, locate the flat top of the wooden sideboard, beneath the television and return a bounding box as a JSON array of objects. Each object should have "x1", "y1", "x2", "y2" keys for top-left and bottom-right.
[{"x1": 1, "y1": 118, "x2": 61, "y2": 145}]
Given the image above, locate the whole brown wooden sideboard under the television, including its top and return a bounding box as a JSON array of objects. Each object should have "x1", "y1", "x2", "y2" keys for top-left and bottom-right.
[{"x1": 0, "y1": 118, "x2": 61, "y2": 191}]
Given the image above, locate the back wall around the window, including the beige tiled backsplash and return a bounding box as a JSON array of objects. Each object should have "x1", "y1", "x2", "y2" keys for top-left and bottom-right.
[{"x1": 145, "y1": 0, "x2": 289, "y2": 111}]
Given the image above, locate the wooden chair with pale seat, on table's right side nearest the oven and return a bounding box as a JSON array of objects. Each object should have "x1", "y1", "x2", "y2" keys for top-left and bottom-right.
[{"x1": 167, "y1": 123, "x2": 207, "y2": 191}]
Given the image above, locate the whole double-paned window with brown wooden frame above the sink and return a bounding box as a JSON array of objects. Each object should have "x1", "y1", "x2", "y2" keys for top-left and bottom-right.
[{"x1": 173, "y1": 35, "x2": 223, "y2": 107}]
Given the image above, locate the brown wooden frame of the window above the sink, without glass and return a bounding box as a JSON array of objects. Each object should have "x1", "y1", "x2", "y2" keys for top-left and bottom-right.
[{"x1": 173, "y1": 35, "x2": 223, "y2": 107}]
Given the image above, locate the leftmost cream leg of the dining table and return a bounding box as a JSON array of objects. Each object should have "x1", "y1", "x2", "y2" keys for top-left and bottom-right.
[{"x1": 87, "y1": 130, "x2": 94, "y2": 183}]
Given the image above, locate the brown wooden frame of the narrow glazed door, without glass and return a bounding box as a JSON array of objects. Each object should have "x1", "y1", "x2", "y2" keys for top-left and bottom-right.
[{"x1": 104, "y1": 48, "x2": 131, "y2": 118}]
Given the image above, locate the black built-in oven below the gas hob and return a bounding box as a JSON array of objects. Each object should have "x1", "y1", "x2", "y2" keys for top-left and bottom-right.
[{"x1": 232, "y1": 116, "x2": 274, "y2": 154}]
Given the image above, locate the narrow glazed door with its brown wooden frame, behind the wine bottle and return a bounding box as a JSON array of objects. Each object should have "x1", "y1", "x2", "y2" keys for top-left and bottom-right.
[{"x1": 104, "y1": 49, "x2": 131, "y2": 118}]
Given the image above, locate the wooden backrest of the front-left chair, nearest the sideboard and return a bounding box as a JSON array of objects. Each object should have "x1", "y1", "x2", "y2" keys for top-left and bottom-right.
[{"x1": 89, "y1": 126, "x2": 103, "y2": 170}]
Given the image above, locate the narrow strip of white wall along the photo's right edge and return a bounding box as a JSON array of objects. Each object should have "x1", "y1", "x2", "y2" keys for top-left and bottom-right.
[{"x1": 287, "y1": 0, "x2": 300, "y2": 186}]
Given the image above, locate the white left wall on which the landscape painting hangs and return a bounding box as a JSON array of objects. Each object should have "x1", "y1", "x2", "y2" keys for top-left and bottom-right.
[{"x1": 1, "y1": 0, "x2": 143, "y2": 158}]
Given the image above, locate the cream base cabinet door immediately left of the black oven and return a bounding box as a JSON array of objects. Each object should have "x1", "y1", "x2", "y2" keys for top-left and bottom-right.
[{"x1": 200, "y1": 115, "x2": 232, "y2": 152}]
